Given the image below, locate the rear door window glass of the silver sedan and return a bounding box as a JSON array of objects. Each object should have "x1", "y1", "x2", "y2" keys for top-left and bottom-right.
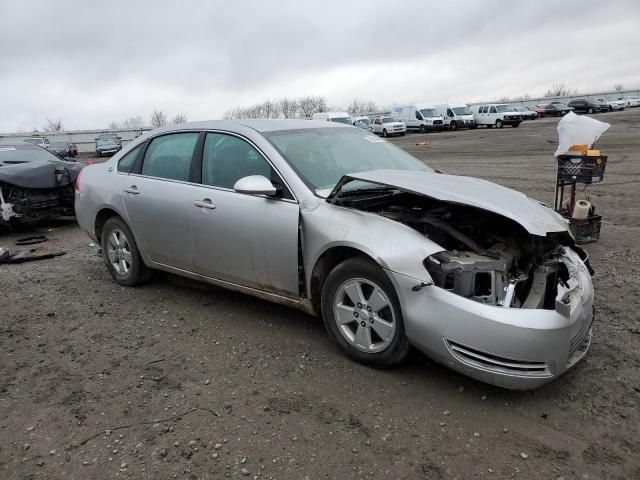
[{"x1": 141, "y1": 132, "x2": 198, "y2": 182}]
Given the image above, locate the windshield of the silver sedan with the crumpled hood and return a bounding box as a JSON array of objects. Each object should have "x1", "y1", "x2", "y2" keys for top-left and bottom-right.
[{"x1": 262, "y1": 128, "x2": 432, "y2": 190}]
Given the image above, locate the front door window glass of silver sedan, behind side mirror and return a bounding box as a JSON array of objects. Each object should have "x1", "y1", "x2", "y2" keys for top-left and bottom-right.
[{"x1": 202, "y1": 133, "x2": 272, "y2": 189}]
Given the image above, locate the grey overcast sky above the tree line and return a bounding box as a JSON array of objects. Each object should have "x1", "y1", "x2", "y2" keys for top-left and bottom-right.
[{"x1": 0, "y1": 0, "x2": 640, "y2": 132}]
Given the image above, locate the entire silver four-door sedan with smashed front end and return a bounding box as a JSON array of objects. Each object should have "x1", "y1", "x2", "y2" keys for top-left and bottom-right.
[{"x1": 76, "y1": 120, "x2": 594, "y2": 389}]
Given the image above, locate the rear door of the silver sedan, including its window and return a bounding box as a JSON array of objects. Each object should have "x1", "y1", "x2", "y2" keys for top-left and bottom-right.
[{"x1": 122, "y1": 132, "x2": 199, "y2": 270}]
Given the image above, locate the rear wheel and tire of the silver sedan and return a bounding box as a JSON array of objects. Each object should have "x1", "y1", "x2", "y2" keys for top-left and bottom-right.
[{"x1": 101, "y1": 217, "x2": 151, "y2": 287}]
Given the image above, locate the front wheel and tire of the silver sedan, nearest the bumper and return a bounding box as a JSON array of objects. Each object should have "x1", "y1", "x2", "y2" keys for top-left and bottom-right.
[{"x1": 321, "y1": 257, "x2": 411, "y2": 368}]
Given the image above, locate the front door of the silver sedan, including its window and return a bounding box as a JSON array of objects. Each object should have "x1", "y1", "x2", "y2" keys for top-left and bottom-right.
[{"x1": 189, "y1": 133, "x2": 299, "y2": 297}]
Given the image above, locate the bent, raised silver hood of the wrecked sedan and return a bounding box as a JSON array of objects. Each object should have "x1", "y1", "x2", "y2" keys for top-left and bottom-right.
[{"x1": 327, "y1": 170, "x2": 568, "y2": 236}]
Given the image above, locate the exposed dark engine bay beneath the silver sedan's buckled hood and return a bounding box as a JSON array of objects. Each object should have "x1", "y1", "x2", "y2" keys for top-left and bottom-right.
[{"x1": 336, "y1": 188, "x2": 574, "y2": 309}]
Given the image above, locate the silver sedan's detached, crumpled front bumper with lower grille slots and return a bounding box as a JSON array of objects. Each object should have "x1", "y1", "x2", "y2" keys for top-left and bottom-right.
[{"x1": 387, "y1": 248, "x2": 594, "y2": 390}]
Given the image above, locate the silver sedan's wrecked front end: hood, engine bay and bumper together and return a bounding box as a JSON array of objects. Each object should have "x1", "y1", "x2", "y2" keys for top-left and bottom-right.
[{"x1": 328, "y1": 172, "x2": 594, "y2": 389}]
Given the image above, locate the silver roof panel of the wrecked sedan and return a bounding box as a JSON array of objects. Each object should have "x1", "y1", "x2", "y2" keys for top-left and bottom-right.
[{"x1": 150, "y1": 119, "x2": 354, "y2": 135}]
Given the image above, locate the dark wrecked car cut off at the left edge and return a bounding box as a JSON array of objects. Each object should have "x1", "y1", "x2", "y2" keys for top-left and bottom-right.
[{"x1": 0, "y1": 142, "x2": 84, "y2": 226}]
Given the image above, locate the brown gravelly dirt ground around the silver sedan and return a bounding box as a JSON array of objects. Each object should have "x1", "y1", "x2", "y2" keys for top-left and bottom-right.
[{"x1": 0, "y1": 108, "x2": 640, "y2": 479}]
